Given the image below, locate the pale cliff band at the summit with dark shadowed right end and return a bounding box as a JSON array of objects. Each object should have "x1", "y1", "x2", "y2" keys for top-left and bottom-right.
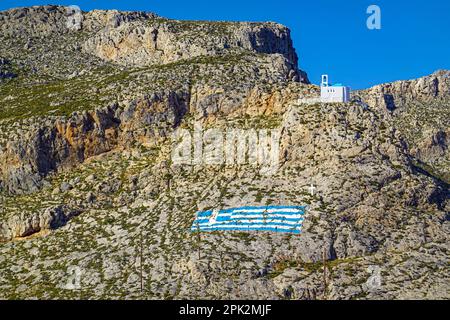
[{"x1": 83, "y1": 19, "x2": 298, "y2": 70}]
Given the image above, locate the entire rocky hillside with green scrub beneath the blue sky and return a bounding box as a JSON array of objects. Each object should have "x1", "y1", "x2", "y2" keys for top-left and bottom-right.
[{"x1": 0, "y1": 6, "x2": 450, "y2": 299}]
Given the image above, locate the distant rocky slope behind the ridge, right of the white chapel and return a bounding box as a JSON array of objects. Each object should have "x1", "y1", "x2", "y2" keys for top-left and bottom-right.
[{"x1": 358, "y1": 70, "x2": 450, "y2": 181}]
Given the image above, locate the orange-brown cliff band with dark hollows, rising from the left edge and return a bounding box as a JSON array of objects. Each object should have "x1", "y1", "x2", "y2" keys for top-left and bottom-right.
[{"x1": 0, "y1": 92, "x2": 187, "y2": 194}]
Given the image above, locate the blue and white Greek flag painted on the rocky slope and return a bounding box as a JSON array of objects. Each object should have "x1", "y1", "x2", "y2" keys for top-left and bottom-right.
[{"x1": 191, "y1": 206, "x2": 306, "y2": 234}]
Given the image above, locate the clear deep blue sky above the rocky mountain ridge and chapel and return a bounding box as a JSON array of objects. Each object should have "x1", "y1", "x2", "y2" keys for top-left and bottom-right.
[{"x1": 0, "y1": 0, "x2": 450, "y2": 89}]
